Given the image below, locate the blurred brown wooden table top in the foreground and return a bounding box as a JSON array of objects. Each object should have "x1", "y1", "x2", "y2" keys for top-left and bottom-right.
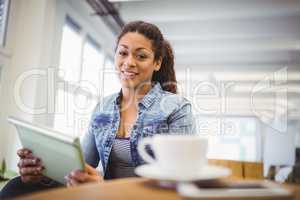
[{"x1": 18, "y1": 178, "x2": 300, "y2": 200}]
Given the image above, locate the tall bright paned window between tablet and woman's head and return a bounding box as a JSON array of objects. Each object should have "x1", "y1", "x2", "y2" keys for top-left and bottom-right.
[{"x1": 53, "y1": 17, "x2": 104, "y2": 136}]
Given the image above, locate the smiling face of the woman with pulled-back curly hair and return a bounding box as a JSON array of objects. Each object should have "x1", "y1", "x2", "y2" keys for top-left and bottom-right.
[{"x1": 115, "y1": 32, "x2": 161, "y2": 88}]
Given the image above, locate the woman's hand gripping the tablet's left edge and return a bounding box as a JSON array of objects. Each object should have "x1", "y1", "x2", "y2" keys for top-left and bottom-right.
[{"x1": 17, "y1": 149, "x2": 45, "y2": 183}]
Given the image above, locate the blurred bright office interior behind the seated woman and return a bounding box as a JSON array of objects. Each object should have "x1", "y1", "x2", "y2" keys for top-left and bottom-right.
[{"x1": 0, "y1": 0, "x2": 300, "y2": 177}]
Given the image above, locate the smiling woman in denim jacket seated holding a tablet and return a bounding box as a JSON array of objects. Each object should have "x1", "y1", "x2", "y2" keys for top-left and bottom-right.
[{"x1": 3, "y1": 21, "x2": 195, "y2": 198}]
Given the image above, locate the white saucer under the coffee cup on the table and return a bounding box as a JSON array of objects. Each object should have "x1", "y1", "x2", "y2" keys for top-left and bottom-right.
[{"x1": 135, "y1": 164, "x2": 231, "y2": 182}]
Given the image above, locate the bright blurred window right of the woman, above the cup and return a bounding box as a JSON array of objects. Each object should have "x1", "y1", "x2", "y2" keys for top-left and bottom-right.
[{"x1": 197, "y1": 117, "x2": 261, "y2": 161}]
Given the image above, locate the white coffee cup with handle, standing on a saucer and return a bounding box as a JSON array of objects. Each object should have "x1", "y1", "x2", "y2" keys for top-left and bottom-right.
[{"x1": 138, "y1": 135, "x2": 208, "y2": 172}]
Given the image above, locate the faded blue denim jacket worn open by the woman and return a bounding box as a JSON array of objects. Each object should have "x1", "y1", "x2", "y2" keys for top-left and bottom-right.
[{"x1": 82, "y1": 83, "x2": 196, "y2": 177}]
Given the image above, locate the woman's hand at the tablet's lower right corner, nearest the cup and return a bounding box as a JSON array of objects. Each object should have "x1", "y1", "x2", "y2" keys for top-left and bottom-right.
[{"x1": 65, "y1": 164, "x2": 103, "y2": 187}]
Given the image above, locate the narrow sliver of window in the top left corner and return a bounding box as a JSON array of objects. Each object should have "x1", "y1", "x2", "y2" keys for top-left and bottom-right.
[{"x1": 0, "y1": 0, "x2": 9, "y2": 46}]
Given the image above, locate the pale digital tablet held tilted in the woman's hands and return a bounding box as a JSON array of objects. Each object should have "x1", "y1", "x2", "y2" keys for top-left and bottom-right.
[{"x1": 8, "y1": 117, "x2": 85, "y2": 184}]
